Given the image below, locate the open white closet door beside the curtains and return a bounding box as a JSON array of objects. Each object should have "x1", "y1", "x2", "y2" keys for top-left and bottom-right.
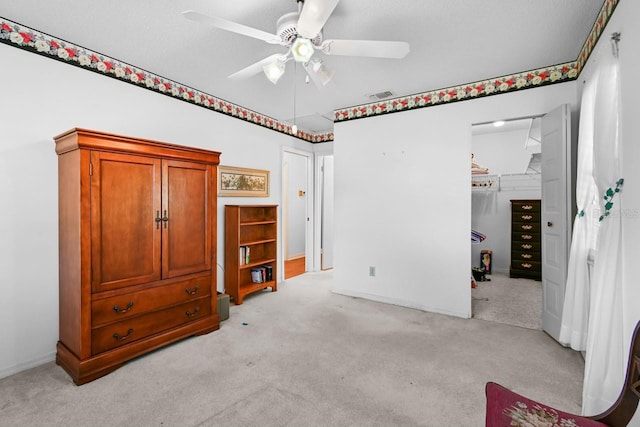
[{"x1": 542, "y1": 105, "x2": 571, "y2": 340}]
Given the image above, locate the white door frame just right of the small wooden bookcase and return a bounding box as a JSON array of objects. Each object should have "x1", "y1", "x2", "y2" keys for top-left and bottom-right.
[{"x1": 280, "y1": 147, "x2": 315, "y2": 278}]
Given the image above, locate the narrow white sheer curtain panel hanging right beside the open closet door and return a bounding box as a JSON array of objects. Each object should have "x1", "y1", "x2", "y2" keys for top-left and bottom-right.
[{"x1": 559, "y1": 73, "x2": 599, "y2": 351}]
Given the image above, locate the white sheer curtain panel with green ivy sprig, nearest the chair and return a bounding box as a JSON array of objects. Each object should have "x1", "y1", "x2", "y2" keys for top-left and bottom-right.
[{"x1": 582, "y1": 48, "x2": 626, "y2": 415}]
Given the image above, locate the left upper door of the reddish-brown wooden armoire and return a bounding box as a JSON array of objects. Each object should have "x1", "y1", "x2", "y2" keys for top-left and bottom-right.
[{"x1": 91, "y1": 152, "x2": 161, "y2": 292}]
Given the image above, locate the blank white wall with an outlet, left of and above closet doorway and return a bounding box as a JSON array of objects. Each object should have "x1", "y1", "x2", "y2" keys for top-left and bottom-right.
[{"x1": 334, "y1": 82, "x2": 577, "y2": 318}]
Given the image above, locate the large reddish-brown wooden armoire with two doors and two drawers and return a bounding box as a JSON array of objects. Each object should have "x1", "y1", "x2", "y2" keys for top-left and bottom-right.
[{"x1": 54, "y1": 128, "x2": 220, "y2": 385}]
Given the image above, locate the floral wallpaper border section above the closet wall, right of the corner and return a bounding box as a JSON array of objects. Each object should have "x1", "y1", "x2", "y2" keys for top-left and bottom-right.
[{"x1": 334, "y1": 0, "x2": 620, "y2": 122}]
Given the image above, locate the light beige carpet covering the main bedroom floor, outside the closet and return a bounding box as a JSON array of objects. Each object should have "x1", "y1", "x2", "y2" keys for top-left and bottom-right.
[{"x1": 0, "y1": 272, "x2": 584, "y2": 427}]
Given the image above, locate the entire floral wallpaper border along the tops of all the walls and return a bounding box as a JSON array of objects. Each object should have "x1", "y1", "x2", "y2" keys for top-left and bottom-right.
[{"x1": 0, "y1": 0, "x2": 620, "y2": 143}]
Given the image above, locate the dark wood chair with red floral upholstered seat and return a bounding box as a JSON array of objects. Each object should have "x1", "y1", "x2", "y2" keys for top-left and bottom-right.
[{"x1": 485, "y1": 322, "x2": 640, "y2": 427}]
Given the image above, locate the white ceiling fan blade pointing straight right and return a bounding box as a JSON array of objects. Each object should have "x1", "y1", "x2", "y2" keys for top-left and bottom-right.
[{"x1": 321, "y1": 40, "x2": 409, "y2": 59}]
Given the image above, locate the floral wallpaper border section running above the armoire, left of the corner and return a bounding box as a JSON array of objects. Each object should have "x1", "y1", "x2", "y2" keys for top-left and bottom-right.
[{"x1": 0, "y1": 17, "x2": 333, "y2": 143}]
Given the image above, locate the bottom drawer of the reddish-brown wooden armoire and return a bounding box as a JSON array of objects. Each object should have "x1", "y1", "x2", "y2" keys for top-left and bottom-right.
[{"x1": 91, "y1": 296, "x2": 211, "y2": 355}]
